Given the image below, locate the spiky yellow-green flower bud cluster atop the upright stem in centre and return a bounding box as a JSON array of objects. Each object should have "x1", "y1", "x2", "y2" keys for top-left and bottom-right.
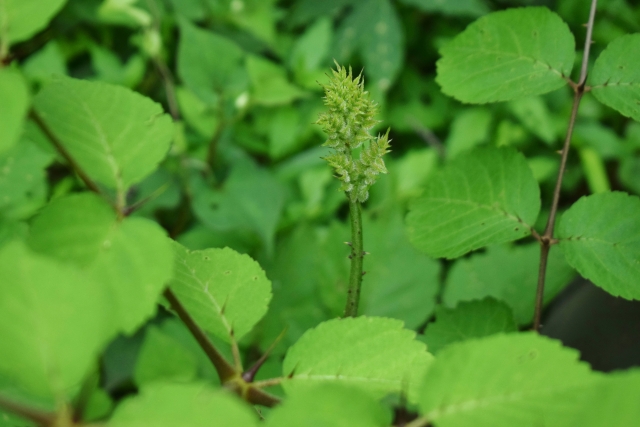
[{"x1": 316, "y1": 63, "x2": 390, "y2": 203}]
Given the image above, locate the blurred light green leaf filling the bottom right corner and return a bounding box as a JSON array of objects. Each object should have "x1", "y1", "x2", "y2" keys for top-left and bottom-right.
[{"x1": 572, "y1": 368, "x2": 640, "y2": 427}]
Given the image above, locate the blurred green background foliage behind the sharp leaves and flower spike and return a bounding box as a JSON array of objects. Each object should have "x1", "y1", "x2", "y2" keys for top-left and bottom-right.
[{"x1": 0, "y1": 0, "x2": 640, "y2": 404}]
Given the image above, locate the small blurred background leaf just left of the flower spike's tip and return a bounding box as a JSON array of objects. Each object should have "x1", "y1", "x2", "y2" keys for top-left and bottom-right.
[{"x1": 247, "y1": 55, "x2": 307, "y2": 106}]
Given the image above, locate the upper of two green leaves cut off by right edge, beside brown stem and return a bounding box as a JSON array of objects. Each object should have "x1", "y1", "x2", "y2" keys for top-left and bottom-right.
[{"x1": 588, "y1": 34, "x2": 640, "y2": 121}]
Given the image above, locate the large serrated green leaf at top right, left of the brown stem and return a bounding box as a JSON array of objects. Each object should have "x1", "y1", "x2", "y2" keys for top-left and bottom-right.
[{"x1": 436, "y1": 7, "x2": 575, "y2": 104}]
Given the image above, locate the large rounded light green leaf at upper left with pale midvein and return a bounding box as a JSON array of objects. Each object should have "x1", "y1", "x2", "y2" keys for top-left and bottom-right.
[{"x1": 34, "y1": 78, "x2": 174, "y2": 193}]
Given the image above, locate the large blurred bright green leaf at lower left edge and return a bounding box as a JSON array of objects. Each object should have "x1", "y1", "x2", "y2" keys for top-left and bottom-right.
[{"x1": 0, "y1": 241, "x2": 113, "y2": 403}]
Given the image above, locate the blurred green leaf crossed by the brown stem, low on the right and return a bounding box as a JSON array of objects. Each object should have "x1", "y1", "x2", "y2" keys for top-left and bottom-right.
[{"x1": 442, "y1": 243, "x2": 575, "y2": 325}]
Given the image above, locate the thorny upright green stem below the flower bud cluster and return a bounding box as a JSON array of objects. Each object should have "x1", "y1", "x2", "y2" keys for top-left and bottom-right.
[{"x1": 344, "y1": 197, "x2": 364, "y2": 317}]
